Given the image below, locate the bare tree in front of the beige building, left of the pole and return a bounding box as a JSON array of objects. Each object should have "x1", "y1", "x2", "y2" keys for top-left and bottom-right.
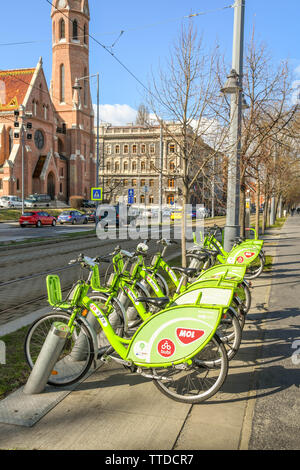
[{"x1": 149, "y1": 24, "x2": 227, "y2": 266}]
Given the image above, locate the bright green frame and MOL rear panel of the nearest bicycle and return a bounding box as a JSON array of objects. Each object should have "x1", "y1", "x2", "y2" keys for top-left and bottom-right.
[{"x1": 47, "y1": 275, "x2": 222, "y2": 368}]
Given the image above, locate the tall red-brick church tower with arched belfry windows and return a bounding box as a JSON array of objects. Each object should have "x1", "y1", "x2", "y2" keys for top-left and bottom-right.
[{"x1": 50, "y1": 0, "x2": 96, "y2": 199}]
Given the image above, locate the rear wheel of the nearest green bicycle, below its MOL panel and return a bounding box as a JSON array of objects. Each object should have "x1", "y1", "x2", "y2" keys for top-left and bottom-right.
[{"x1": 153, "y1": 335, "x2": 228, "y2": 404}]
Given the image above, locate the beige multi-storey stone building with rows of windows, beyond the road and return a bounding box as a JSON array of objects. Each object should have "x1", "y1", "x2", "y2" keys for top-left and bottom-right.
[{"x1": 95, "y1": 123, "x2": 222, "y2": 208}]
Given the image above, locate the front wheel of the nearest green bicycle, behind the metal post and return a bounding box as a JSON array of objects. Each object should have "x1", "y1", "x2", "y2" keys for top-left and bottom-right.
[{"x1": 24, "y1": 312, "x2": 94, "y2": 387}]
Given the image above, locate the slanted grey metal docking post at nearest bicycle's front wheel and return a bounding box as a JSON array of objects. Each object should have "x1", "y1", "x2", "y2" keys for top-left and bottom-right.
[{"x1": 23, "y1": 322, "x2": 69, "y2": 395}]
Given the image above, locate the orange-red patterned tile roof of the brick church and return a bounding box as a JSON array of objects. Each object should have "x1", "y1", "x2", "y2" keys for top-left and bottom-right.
[{"x1": 0, "y1": 68, "x2": 36, "y2": 112}]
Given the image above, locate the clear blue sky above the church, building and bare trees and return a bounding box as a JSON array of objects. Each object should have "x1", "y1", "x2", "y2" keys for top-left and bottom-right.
[{"x1": 0, "y1": 0, "x2": 300, "y2": 122}]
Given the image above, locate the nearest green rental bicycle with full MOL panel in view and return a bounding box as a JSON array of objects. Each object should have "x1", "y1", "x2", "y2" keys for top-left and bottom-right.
[{"x1": 25, "y1": 253, "x2": 228, "y2": 403}]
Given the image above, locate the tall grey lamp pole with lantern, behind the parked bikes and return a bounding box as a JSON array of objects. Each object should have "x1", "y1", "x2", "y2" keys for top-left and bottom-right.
[{"x1": 222, "y1": 0, "x2": 245, "y2": 251}]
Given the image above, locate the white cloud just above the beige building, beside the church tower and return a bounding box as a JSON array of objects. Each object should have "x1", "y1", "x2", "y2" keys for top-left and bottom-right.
[{"x1": 94, "y1": 104, "x2": 137, "y2": 126}]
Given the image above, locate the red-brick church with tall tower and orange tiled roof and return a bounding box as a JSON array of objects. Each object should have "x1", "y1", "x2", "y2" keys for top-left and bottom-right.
[{"x1": 0, "y1": 0, "x2": 96, "y2": 201}]
